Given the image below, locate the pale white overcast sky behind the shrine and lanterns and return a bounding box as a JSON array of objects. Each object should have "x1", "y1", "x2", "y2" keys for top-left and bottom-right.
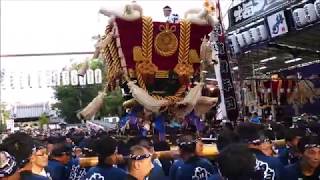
[{"x1": 0, "y1": 0, "x2": 240, "y2": 104}]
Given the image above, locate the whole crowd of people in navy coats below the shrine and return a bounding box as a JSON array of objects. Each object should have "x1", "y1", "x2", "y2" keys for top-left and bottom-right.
[{"x1": 0, "y1": 116, "x2": 320, "y2": 180}]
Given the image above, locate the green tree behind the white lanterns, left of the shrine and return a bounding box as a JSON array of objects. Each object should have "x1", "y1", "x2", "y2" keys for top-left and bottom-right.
[{"x1": 53, "y1": 59, "x2": 123, "y2": 123}]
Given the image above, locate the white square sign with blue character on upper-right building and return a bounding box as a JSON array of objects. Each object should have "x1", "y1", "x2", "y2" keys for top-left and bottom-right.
[{"x1": 268, "y1": 11, "x2": 288, "y2": 38}]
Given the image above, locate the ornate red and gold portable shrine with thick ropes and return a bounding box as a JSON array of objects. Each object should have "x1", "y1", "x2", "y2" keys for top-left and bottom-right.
[{"x1": 80, "y1": 0, "x2": 218, "y2": 119}]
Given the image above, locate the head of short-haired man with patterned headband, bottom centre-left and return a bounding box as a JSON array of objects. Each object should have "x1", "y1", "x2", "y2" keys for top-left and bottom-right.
[{"x1": 127, "y1": 145, "x2": 154, "y2": 180}]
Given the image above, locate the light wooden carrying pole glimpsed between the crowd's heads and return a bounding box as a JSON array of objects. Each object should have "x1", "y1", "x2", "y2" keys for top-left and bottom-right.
[{"x1": 80, "y1": 140, "x2": 285, "y2": 167}]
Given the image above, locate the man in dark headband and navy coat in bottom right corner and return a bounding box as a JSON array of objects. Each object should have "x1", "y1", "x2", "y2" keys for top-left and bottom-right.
[{"x1": 286, "y1": 136, "x2": 320, "y2": 180}]
